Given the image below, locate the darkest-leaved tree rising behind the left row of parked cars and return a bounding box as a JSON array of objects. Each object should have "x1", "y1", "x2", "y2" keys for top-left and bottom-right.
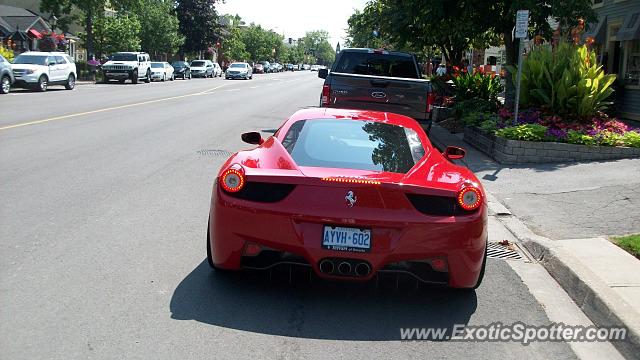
[{"x1": 176, "y1": 0, "x2": 221, "y2": 52}]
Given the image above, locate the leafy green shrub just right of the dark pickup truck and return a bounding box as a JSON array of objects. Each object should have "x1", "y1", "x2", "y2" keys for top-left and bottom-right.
[{"x1": 451, "y1": 72, "x2": 503, "y2": 103}]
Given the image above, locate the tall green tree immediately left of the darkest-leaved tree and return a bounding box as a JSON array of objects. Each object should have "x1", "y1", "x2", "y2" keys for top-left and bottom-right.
[{"x1": 140, "y1": 0, "x2": 184, "y2": 54}]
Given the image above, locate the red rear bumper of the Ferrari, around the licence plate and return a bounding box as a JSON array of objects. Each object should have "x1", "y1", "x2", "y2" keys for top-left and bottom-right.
[{"x1": 209, "y1": 186, "x2": 487, "y2": 288}]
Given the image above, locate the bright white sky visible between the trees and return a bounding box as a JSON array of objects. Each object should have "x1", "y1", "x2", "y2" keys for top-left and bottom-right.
[{"x1": 216, "y1": 0, "x2": 367, "y2": 47}]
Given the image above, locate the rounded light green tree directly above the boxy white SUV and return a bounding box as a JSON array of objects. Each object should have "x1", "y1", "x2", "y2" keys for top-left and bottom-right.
[{"x1": 89, "y1": 14, "x2": 141, "y2": 54}]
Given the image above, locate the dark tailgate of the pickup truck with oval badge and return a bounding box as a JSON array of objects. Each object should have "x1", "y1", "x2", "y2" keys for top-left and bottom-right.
[{"x1": 329, "y1": 72, "x2": 431, "y2": 120}]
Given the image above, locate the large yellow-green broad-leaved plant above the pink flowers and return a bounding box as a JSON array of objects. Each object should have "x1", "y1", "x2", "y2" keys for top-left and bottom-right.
[{"x1": 512, "y1": 44, "x2": 616, "y2": 118}]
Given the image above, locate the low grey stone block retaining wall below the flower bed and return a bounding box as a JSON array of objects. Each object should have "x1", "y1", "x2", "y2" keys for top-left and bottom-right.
[{"x1": 464, "y1": 127, "x2": 640, "y2": 164}]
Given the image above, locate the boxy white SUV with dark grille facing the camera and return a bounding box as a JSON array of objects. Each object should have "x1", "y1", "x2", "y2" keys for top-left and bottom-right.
[{"x1": 102, "y1": 52, "x2": 151, "y2": 84}]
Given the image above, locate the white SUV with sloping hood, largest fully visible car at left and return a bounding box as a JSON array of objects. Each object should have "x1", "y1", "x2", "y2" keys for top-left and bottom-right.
[{"x1": 12, "y1": 51, "x2": 77, "y2": 91}]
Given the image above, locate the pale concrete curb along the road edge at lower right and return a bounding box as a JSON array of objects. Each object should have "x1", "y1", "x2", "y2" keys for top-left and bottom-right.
[{"x1": 489, "y1": 210, "x2": 640, "y2": 359}]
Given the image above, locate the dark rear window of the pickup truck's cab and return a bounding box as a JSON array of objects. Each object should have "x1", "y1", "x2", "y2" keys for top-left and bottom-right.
[{"x1": 335, "y1": 52, "x2": 420, "y2": 79}]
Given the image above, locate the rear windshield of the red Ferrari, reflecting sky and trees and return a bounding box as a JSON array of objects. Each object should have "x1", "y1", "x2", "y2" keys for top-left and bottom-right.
[{"x1": 282, "y1": 119, "x2": 425, "y2": 174}]
